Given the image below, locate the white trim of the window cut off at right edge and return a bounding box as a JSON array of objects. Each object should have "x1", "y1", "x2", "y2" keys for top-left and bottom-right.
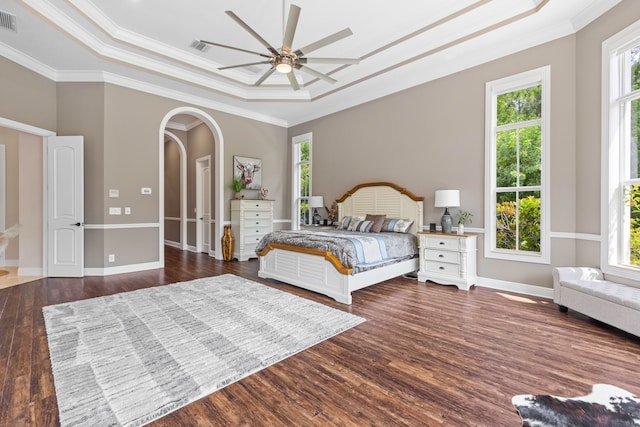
[{"x1": 600, "y1": 22, "x2": 640, "y2": 280}]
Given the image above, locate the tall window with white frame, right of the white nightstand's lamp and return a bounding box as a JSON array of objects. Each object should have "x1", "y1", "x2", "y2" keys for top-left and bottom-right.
[{"x1": 485, "y1": 67, "x2": 550, "y2": 264}]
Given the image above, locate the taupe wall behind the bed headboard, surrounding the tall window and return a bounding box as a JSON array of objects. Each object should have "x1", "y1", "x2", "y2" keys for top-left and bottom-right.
[{"x1": 289, "y1": 36, "x2": 576, "y2": 286}]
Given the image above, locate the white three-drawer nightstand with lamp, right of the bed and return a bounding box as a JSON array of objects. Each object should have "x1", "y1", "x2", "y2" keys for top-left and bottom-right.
[{"x1": 418, "y1": 233, "x2": 478, "y2": 290}]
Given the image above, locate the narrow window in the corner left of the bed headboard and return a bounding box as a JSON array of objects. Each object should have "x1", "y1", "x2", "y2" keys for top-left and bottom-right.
[{"x1": 291, "y1": 133, "x2": 311, "y2": 230}]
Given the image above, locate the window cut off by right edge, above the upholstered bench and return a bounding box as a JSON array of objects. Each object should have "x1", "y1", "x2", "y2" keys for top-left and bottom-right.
[{"x1": 601, "y1": 24, "x2": 640, "y2": 280}]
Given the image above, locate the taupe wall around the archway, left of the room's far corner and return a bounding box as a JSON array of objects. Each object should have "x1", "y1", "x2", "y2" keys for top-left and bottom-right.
[{"x1": 0, "y1": 64, "x2": 289, "y2": 269}]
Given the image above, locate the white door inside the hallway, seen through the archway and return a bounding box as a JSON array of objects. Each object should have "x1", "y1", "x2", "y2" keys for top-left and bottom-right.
[{"x1": 196, "y1": 156, "x2": 211, "y2": 254}]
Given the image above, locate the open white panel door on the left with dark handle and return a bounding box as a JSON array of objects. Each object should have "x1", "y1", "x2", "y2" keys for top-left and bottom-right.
[{"x1": 47, "y1": 136, "x2": 84, "y2": 277}]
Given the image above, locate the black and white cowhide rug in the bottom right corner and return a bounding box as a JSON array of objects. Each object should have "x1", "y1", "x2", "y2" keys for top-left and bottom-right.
[{"x1": 511, "y1": 384, "x2": 640, "y2": 427}]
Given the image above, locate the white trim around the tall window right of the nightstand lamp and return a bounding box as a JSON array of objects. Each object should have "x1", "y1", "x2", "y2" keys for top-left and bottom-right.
[{"x1": 484, "y1": 65, "x2": 551, "y2": 264}]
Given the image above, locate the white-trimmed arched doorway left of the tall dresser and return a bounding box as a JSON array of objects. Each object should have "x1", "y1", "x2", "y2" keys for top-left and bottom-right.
[{"x1": 158, "y1": 107, "x2": 224, "y2": 267}]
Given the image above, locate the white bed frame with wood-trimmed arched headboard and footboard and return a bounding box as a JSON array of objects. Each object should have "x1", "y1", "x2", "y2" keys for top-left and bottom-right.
[{"x1": 256, "y1": 182, "x2": 424, "y2": 304}]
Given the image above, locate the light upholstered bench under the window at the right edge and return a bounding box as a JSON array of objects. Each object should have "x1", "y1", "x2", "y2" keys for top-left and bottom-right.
[{"x1": 553, "y1": 267, "x2": 640, "y2": 336}]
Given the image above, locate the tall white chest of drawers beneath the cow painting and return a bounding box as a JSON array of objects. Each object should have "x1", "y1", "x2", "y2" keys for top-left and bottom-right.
[{"x1": 231, "y1": 200, "x2": 273, "y2": 261}]
